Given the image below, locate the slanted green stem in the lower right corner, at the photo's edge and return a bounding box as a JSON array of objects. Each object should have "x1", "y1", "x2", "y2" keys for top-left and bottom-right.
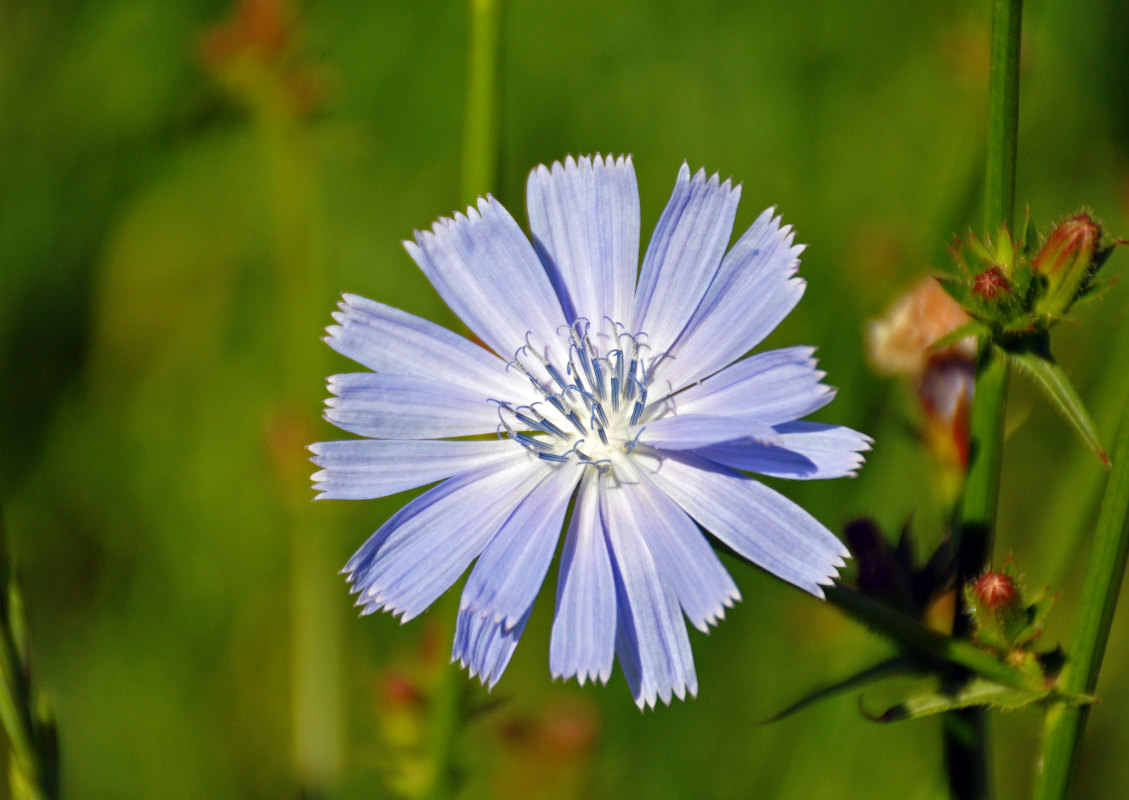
[{"x1": 1034, "y1": 401, "x2": 1129, "y2": 800}]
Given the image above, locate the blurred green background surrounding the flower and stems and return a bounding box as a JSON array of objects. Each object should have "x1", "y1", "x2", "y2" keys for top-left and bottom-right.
[{"x1": 0, "y1": 0, "x2": 1129, "y2": 798}]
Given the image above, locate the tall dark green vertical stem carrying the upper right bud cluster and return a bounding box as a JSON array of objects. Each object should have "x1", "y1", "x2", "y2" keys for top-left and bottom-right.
[{"x1": 944, "y1": 0, "x2": 1023, "y2": 800}]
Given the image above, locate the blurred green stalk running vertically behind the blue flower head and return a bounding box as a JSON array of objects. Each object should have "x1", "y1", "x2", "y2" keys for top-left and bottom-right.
[{"x1": 422, "y1": 0, "x2": 501, "y2": 800}]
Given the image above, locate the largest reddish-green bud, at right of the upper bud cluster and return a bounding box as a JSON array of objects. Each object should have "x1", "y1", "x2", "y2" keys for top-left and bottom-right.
[{"x1": 1032, "y1": 213, "x2": 1104, "y2": 316}]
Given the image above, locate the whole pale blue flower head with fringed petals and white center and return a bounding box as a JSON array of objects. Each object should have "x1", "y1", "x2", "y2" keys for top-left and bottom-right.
[{"x1": 310, "y1": 156, "x2": 869, "y2": 707}]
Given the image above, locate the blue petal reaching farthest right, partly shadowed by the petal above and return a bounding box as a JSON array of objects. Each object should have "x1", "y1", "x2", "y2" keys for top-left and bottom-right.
[{"x1": 698, "y1": 421, "x2": 873, "y2": 481}]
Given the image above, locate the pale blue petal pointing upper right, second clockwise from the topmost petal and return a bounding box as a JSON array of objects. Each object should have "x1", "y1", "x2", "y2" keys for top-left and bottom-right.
[{"x1": 660, "y1": 209, "x2": 805, "y2": 390}]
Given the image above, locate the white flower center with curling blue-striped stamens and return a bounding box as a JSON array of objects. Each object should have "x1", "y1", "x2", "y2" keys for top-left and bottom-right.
[{"x1": 495, "y1": 318, "x2": 647, "y2": 473}]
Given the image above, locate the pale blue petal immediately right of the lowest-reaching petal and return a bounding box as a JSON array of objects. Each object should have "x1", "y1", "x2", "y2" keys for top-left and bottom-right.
[{"x1": 623, "y1": 474, "x2": 741, "y2": 632}]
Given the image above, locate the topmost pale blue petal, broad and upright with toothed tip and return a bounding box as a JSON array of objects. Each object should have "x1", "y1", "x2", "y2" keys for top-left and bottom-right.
[{"x1": 525, "y1": 156, "x2": 639, "y2": 323}]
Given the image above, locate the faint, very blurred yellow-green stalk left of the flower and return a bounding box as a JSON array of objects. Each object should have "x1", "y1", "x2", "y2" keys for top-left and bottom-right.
[{"x1": 251, "y1": 85, "x2": 344, "y2": 798}]
